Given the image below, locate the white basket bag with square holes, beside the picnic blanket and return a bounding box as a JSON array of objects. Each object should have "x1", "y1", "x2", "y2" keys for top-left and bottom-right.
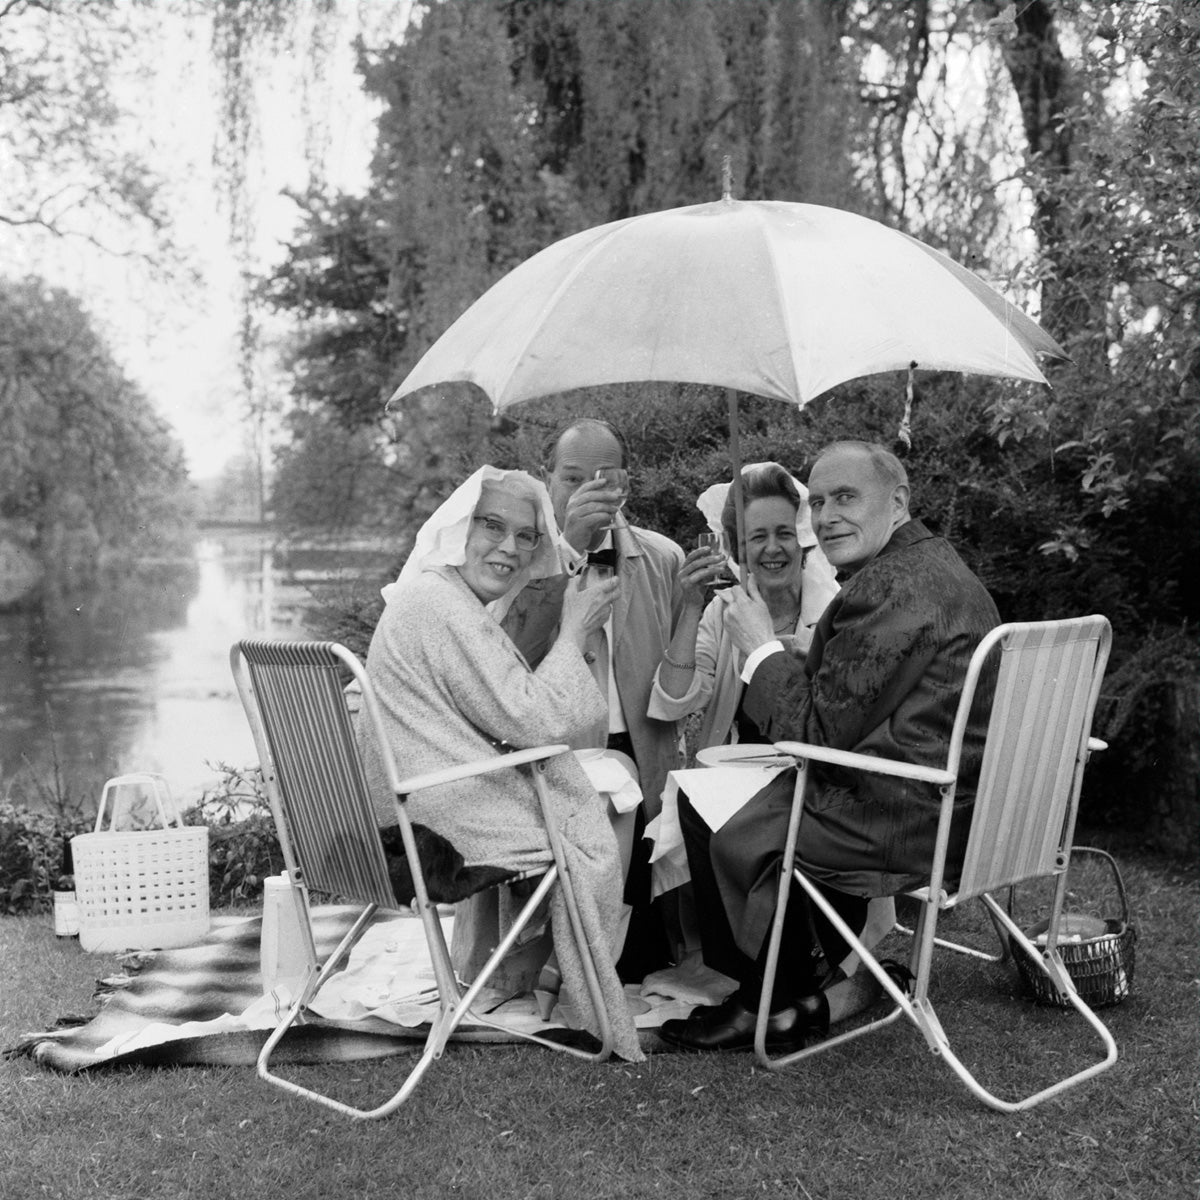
[{"x1": 71, "y1": 772, "x2": 209, "y2": 953}]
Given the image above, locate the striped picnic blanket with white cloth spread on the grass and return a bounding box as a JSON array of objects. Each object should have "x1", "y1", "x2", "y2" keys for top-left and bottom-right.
[{"x1": 4, "y1": 905, "x2": 691, "y2": 1073}]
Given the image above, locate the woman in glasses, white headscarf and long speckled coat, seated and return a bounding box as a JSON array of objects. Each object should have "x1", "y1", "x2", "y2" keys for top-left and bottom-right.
[{"x1": 352, "y1": 467, "x2": 641, "y2": 1060}]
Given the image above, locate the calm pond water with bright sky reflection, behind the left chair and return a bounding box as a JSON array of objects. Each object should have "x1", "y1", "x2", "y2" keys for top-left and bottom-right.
[{"x1": 0, "y1": 532, "x2": 386, "y2": 810}]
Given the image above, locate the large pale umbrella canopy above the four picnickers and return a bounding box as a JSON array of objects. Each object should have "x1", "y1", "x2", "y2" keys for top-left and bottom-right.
[{"x1": 391, "y1": 198, "x2": 1066, "y2": 413}]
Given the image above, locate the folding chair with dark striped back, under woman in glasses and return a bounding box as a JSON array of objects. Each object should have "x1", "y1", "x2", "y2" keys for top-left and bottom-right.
[{"x1": 230, "y1": 641, "x2": 612, "y2": 1118}]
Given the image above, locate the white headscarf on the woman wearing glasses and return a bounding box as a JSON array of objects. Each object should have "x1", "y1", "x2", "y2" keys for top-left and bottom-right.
[{"x1": 383, "y1": 466, "x2": 563, "y2": 620}]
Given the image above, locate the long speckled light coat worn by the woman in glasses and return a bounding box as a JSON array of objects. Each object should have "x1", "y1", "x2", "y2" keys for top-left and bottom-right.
[{"x1": 360, "y1": 565, "x2": 642, "y2": 1061}]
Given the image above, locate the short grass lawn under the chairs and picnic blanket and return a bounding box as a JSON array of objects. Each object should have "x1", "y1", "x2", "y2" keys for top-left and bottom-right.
[{"x1": 0, "y1": 839, "x2": 1200, "y2": 1200}]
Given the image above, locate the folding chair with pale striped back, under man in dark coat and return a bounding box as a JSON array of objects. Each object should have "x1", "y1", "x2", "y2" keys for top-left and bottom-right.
[{"x1": 755, "y1": 617, "x2": 1117, "y2": 1112}]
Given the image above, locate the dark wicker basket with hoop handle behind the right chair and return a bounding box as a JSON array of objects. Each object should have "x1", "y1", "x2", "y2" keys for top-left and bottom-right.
[{"x1": 1009, "y1": 846, "x2": 1138, "y2": 1008}]
